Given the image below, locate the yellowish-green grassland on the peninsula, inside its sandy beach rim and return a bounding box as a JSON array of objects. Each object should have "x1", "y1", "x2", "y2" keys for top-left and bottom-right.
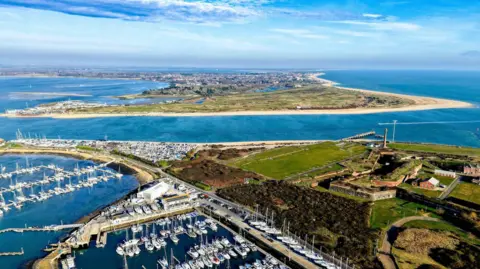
[{"x1": 76, "y1": 85, "x2": 414, "y2": 113}]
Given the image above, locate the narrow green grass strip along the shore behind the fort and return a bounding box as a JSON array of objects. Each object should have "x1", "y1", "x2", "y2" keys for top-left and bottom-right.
[{"x1": 388, "y1": 143, "x2": 480, "y2": 157}]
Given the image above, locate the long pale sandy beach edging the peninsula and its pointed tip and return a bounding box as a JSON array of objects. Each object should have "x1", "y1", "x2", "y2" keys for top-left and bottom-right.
[{"x1": 0, "y1": 73, "x2": 473, "y2": 119}]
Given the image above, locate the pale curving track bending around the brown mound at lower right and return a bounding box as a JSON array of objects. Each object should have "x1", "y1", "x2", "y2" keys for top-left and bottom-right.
[{"x1": 378, "y1": 216, "x2": 440, "y2": 269}]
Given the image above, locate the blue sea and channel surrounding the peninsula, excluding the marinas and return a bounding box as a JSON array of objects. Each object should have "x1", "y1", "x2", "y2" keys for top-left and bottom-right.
[{"x1": 0, "y1": 71, "x2": 480, "y2": 147}]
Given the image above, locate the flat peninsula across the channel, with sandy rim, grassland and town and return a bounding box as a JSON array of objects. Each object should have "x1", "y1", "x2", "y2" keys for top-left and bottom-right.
[{"x1": 3, "y1": 72, "x2": 472, "y2": 118}]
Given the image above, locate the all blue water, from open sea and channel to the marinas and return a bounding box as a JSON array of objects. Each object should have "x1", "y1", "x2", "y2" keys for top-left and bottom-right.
[{"x1": 0, "y1": 71, "x2": 480, "y2": 269}]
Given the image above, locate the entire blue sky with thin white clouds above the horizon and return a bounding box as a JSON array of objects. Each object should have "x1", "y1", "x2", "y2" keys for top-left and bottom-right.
[{"x1": 0, "y1": 0, "x2": 480, "y2": 69}]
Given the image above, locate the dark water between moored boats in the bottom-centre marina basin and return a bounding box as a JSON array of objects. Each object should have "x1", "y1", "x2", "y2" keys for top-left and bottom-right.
[{"x1": 76, "y1": 217, "x2": 264, "y2": 269}]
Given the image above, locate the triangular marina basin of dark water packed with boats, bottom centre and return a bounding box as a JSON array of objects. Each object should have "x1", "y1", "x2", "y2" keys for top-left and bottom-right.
[{"x1": 70, "y1": 213, "x2": 287, "y2": 269}]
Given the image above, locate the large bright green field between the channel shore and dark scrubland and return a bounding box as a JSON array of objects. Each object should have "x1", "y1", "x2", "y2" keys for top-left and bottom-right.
[{"x1": 232, "y1": 142, "x2": 366, "y2": 179}]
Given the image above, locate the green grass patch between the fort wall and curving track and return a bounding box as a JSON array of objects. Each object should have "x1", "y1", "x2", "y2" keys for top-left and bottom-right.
[{"x1": 370, "y1": 198, "x2": 438, "y2": 229}]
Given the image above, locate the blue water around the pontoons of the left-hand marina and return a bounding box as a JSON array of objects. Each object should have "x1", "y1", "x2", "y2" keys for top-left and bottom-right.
[{"x1": 0, "y1": 155, "x2": 138, "y2": 269}]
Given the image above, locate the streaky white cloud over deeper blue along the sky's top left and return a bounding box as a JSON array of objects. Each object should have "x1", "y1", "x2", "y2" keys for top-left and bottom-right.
[{"x1": 0, "y1": 0, "x2": 262, "y2": 23}]
